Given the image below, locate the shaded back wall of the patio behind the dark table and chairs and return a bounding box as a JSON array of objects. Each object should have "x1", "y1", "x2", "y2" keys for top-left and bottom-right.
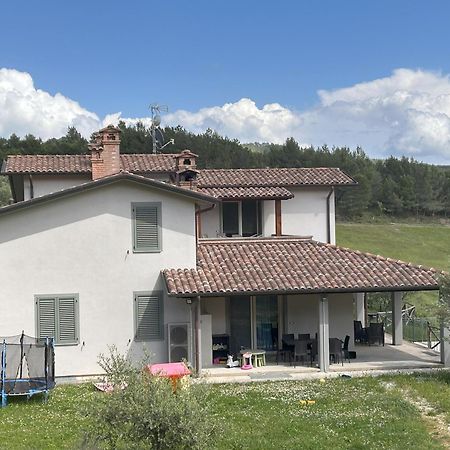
[{"x1": 285, "y1": 294, "x2": 354, "y2": 349}]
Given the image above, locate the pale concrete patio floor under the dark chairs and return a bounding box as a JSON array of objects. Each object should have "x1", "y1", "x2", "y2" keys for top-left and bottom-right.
[{"x1": 202, "y1": 338, "x2": 443, "y2": 383}]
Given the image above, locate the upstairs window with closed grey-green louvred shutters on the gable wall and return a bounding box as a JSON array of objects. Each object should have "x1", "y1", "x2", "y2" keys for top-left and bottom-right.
[{"x1": 132, "y1": 203, "x2": 161, "y2": 253}]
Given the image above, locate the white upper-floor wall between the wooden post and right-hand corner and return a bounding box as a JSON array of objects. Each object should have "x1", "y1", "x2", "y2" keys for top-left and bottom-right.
[{"x1": 281, "y1": 187, "x2": 336, "y2": 244}]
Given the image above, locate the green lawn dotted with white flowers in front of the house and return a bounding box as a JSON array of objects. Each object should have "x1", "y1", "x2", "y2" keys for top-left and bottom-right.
[{"x1": 0, "y1": 373, "x2": 450, "y2": 449}]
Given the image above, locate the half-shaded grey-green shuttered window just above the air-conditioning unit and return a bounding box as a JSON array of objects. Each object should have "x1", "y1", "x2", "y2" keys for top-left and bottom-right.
[{"x1": 134, "y1": 291, "x2": 164, "y2": 341}]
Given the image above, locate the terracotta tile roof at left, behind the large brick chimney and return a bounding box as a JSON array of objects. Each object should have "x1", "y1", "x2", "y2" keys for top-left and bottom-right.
[{"x1": 2, "y1": 153, "x2": 176, "y2": 175}]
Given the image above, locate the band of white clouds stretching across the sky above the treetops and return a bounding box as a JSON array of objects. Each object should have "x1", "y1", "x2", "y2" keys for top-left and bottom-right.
[{"x1": 0, "y1": 69, "x2": 450, "y2": 164}]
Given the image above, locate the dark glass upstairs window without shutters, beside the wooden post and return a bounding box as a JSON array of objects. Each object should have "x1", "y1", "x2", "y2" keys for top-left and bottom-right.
[{"x1": 222, "y1": 200, "x2": 262, "y2": 237}]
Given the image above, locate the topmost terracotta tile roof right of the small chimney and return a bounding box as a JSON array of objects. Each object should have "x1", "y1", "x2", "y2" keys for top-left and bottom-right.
[{"x1": 198, "y1": 167, "x2": 356, "y2": 187}]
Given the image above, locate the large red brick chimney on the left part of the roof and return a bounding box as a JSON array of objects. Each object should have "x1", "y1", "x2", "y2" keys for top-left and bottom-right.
[{"x1": 89, "y1": 125, "x2": 120, "y2": 180}]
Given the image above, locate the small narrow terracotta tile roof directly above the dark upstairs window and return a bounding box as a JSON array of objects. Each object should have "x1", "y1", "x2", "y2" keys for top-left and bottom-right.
[{"x1": 198, "y1": 186, "x2": 294, "y2": 200}]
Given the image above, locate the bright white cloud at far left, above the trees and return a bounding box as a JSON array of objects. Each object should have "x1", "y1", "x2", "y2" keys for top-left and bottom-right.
[{"x1": 0, "y1": 69, "x2": 100, "y2": 139}]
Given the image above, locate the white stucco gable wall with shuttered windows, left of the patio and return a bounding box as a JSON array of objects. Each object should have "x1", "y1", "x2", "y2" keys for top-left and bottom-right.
[{"x1": 0, "y1": 181, "x2": 199, "y2": 376}]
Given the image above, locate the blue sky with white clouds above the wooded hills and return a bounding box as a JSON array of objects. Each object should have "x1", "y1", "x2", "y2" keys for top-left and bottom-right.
[{"x1": 0, "y1": 0, "x2": 450, "y2": 162}]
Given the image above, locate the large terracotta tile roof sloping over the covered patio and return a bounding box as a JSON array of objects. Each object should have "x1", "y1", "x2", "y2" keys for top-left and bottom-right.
[{"x1": 163, "y1": 238, "x2": 438, "y2": 296}]
